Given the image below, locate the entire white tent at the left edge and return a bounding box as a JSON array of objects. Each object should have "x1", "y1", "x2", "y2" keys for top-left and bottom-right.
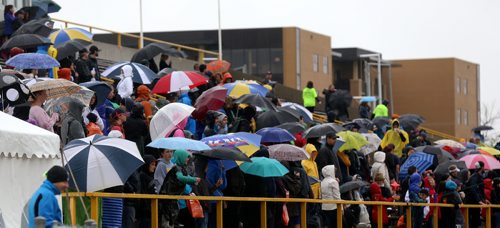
[{"x1": 0, "y1": 112, "x2": 61, "y2": 227}]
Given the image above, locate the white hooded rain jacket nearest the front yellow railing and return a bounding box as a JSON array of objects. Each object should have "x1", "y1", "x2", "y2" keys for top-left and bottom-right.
[{"x1": 321, "y1": 165, "x2": 340, "y2": 211}]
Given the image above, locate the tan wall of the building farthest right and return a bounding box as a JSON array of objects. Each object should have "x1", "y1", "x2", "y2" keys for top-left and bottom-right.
[{"x1": 392, "y1": 58, "x2": 479, "y2": 137}]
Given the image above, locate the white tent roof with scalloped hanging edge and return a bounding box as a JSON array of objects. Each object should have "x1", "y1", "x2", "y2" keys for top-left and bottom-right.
[{"x1": 0, "y1": 112, "x2": 60, "y2": 158}]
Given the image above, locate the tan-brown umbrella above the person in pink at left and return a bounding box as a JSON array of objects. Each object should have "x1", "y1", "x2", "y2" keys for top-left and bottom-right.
[{"x1": 29, "y1": 79, "x2": 81, "y2": 99}]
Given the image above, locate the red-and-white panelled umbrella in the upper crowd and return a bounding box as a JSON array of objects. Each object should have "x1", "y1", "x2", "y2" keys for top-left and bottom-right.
[{"x1": 153, "y1": 71, "x2": 207, "y2": 94}]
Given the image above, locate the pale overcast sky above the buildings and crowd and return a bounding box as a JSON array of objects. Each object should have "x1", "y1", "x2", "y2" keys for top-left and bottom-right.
[{"x1": 52, "y1": 0, "x2": 500, "y2": 107}]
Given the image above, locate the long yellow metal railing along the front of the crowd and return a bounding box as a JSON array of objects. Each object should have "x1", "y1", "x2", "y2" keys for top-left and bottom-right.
[{"x1": 63, "y1": 192, "x2": 500, "y2": 228}]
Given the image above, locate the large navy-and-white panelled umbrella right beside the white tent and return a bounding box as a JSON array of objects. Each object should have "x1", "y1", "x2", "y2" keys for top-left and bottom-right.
[{"x1": 64, "y1": 135, "x2": 144, "y2": 192}]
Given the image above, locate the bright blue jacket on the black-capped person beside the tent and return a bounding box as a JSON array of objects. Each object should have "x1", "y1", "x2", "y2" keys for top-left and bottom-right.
[{"x1": 28, "y1": 180, "x2": 62, "y2": 228}]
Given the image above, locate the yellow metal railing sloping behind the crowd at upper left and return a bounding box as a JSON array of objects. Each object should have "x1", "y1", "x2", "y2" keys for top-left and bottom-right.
[{"x1": 51, "y1": 18, "x2": 219, "y2": 61}]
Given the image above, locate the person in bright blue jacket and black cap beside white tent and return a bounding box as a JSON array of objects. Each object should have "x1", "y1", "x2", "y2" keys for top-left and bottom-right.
[{"x1": 28, "y1": 165, "x2": 69, "y2": 228}]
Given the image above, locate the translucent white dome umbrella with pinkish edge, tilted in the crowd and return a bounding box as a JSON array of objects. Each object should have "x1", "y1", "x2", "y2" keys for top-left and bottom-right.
[{"x1": 149, "y1": 103, "x2": 194, "y2": 140}]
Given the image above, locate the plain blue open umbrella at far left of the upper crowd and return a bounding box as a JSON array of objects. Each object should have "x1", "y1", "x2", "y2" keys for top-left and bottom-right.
[{"x1": 5, "y1": 53, "x2": 59, "y2": 69}]
